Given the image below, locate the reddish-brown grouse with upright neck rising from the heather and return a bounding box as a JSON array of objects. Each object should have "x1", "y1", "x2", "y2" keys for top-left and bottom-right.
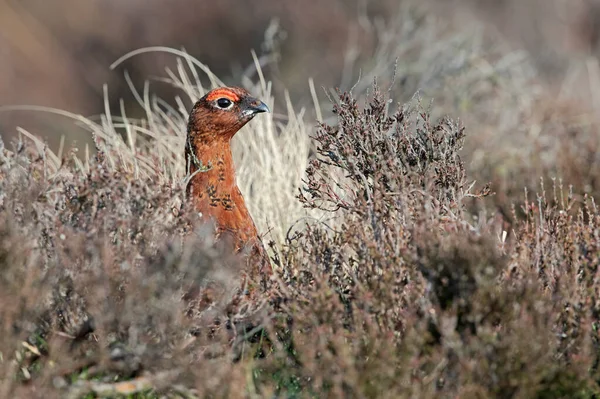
[{"x1": 185, "y1": 87, "x2": 272, "y2": 287}]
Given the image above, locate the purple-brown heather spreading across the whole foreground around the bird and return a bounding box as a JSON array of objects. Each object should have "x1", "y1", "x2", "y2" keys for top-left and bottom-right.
[{"x1": 0, "y1": 85, "x2": 600, "y2": 398}]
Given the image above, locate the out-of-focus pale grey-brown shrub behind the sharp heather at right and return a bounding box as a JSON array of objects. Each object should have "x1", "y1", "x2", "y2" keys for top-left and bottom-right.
[{"x1": 344, "y1": 2, "x2": 598, "y2": 219}]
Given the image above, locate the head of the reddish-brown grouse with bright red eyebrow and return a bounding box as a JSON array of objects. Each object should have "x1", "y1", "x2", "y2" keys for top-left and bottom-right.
[{"x1": 188, "y1": 87, "x2": 269, "y2": 142}]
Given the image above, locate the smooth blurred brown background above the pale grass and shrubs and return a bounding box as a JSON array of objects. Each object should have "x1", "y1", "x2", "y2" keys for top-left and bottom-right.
[{"x1": 0, "y1": 0, "x2": 600, "y2": 152}]
